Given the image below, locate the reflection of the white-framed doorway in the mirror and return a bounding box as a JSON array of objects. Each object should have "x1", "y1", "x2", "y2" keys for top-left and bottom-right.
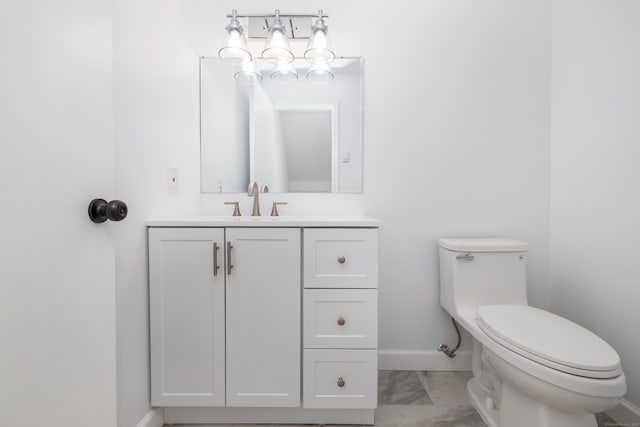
[{"x1": 274, "y1": 104, "x2": 339, "y2": 193}]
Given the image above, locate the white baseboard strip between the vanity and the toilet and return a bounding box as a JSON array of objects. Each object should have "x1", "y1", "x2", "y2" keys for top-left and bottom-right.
[{"x1": 378, "y1": 349, "x2": 471, "y2": 371}]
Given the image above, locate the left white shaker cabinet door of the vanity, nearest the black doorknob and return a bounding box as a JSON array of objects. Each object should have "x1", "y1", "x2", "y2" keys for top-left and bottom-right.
[{"x1": 149, "y1": 228, "x2": 225, "y2": 406}]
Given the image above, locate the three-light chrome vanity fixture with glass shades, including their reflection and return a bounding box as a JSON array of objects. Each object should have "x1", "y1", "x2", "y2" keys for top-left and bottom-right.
[{"x1": 218, "y1": 9, "x2": 336, "y2": 83}]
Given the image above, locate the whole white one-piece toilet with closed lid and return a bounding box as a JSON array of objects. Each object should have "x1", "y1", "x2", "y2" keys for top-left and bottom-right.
[{"x1": 439, "y1": 239, "x2": 627, "y2": 427}]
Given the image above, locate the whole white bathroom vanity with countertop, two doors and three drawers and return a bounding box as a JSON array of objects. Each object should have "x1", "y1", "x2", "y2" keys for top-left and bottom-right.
[{"x1": 147, "y1": 217, "x2": 380, "y2": 424}]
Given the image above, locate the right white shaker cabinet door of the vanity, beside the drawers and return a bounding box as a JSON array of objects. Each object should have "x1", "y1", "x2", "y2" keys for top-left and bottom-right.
[{"x1": 227, "y1": 228, "x2": 301, "y2": 407}]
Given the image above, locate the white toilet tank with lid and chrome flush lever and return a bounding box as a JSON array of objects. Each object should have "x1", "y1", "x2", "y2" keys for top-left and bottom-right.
[{"x1": 438, "y1": 238, "x2": 528, "y2": 317}]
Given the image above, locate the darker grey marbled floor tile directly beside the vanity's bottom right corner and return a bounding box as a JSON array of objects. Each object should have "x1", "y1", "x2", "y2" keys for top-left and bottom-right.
[{"x1": 378, "y1": 371, "x2": 433, "y2": 405}]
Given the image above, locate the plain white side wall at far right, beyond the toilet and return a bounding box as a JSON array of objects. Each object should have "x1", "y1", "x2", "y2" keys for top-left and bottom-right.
[{"x1": 551, "y1": 0, "x2": 640, "y2": 406}]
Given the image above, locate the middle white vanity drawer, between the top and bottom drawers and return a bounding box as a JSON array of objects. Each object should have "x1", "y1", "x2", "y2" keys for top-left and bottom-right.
[{"x1": 303, "y1": 289, "x2": 378, "y2": 349}]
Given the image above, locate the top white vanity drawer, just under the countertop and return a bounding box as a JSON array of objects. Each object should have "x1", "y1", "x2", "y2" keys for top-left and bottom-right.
[{"x1": 304, "y1": 228, "x2": 378, "y2": 288}]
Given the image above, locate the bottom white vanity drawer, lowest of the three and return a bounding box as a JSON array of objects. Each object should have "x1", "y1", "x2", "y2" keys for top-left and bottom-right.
[{"x1": 302, "y1": 350, "x2": 378, "y2": 409}]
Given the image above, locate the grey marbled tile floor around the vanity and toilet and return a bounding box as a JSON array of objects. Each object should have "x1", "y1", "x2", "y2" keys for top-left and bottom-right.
[{"x1": 162, "y1": 371, "x2": 621, "y2": 427}]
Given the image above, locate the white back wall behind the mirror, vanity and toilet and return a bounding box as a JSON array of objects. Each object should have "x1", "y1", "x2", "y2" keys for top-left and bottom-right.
[{"x1": 114, "y1": 0, "x2": 550, "y2": 427}]
